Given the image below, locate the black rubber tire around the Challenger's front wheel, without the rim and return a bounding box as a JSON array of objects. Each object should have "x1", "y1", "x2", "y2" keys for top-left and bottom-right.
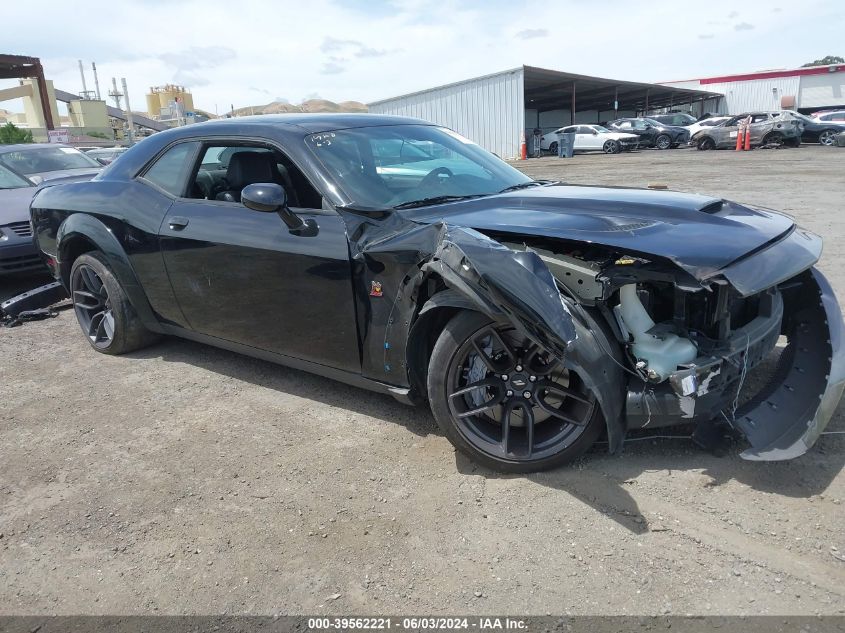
[{"x1": 427, "y1": 310, "x2": 605, "y2": 473}]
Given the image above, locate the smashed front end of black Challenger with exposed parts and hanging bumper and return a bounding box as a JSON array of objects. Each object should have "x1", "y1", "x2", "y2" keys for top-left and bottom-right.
[{"x1": 502, "y1": 230, "x2": 845, "y2": 460}]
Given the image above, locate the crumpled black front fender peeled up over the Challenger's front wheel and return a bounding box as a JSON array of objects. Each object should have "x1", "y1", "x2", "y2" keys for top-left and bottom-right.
[{"x1": 361, "y1": 222, "x2": 624, "y2": 452}]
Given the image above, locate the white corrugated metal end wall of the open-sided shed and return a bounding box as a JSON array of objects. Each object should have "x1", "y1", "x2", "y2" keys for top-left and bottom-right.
[{"x1": 369, "y1": 68, "x2": 525, "y2": 158}]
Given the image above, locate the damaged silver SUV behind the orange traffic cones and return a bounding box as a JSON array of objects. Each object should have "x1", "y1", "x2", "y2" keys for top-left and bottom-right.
[{"x1": 690, "y1": 111, "x2": 804, "y2": 150}]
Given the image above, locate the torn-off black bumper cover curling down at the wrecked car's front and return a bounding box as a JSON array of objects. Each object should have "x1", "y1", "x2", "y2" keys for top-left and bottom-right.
[{"x1": 732, "y1": 268, "x2": 845, "y2": 461}]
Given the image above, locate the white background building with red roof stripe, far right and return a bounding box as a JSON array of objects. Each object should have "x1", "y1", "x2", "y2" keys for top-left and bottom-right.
[{"x1": 661, "y1": 64, "x2": 845, "y2": 114}]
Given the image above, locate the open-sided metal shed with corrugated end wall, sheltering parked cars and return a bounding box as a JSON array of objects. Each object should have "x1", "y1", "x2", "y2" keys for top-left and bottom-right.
[{"x1": 368, "y1": 66, "x2": 722, "y2": 158}]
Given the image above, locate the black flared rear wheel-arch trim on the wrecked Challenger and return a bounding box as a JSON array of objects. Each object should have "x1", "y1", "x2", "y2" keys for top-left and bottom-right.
[{"x1": 56, "y1": 213, "x2": 161, "y2": 332}]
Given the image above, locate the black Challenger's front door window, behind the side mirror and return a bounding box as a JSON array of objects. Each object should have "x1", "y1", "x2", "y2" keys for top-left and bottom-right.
[{"x1": 188, "y1": 142, "x2": 323, "y2": 209}]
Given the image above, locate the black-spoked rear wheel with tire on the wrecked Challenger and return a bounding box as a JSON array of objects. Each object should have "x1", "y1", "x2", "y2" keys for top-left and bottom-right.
[{"x1": 70, "y1": 252, "x2": 158, "y2": 354}]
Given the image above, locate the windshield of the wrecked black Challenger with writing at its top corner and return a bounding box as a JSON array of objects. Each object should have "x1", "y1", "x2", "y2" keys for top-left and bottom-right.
[{"x1": 306, "y1": 125, "x2": 533, "y2": 209}]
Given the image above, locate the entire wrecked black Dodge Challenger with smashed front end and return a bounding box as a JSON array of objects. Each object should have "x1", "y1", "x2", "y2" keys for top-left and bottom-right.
[{"x1": 31, "y1": 114, "x2": 845, "y2": 471}]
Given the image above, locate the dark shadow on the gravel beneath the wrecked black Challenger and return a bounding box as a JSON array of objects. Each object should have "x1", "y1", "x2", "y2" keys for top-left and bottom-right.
[{"x1": 127, "y1": 338, "x2": 845, "y2": 534}]
